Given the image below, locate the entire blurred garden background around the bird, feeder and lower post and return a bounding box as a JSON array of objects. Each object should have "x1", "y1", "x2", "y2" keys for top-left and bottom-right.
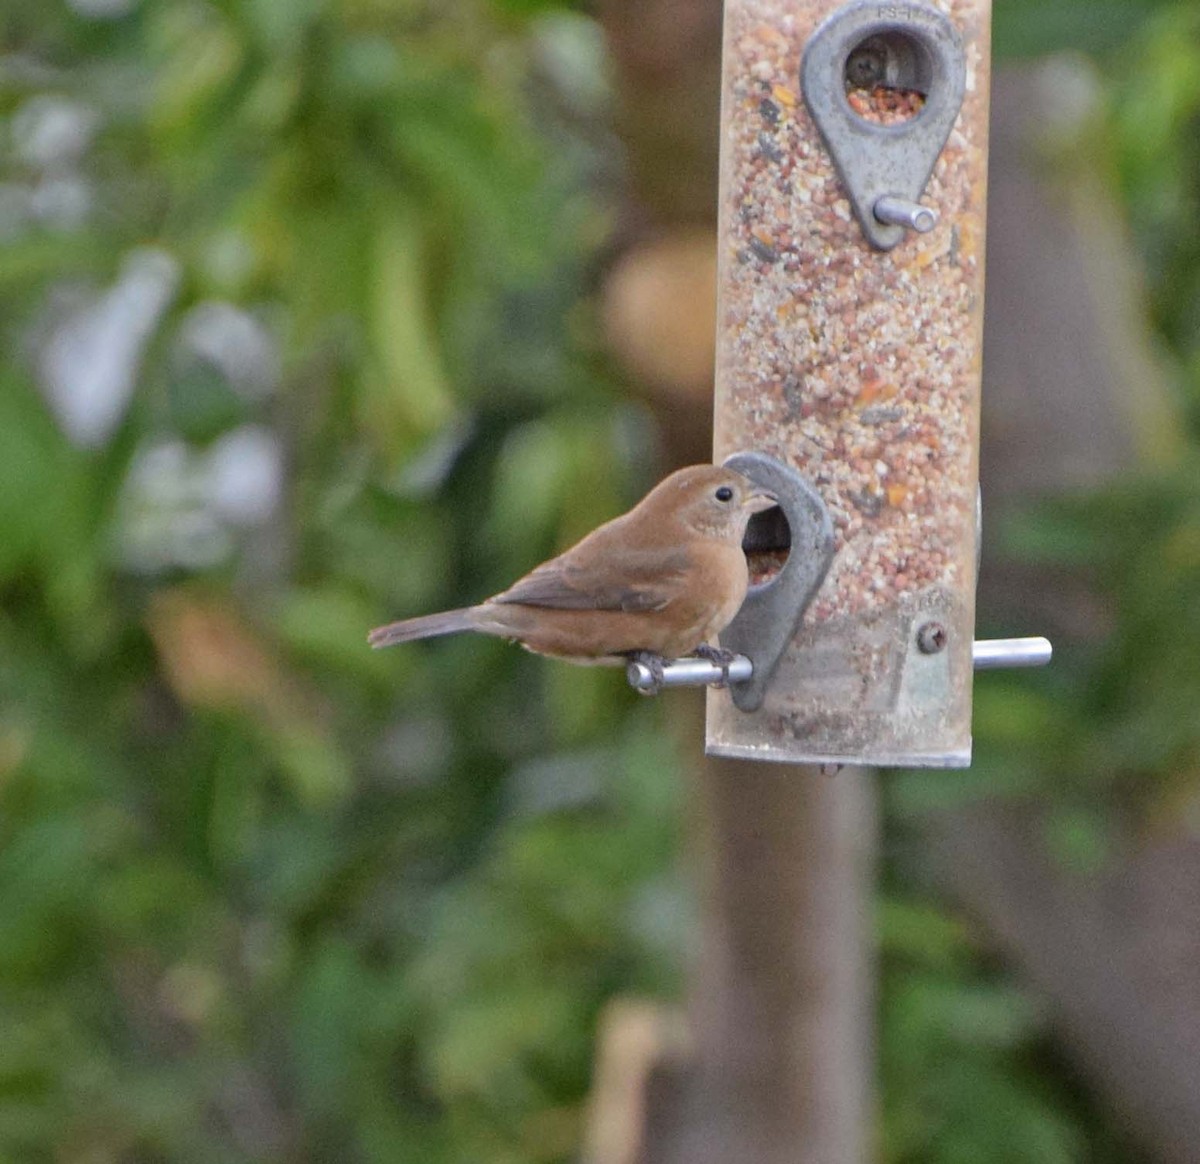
[{"x1": 0, "y1": 0, "x2": 1200, "y2": 1164}]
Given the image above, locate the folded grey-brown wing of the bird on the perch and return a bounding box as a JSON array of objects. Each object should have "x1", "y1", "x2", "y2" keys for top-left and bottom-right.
[{"x1": 491, "y1": 550, "x2": 690, "y2": 613}]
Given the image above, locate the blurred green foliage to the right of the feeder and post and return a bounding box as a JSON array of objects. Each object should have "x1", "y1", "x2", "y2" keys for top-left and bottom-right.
[{"x1": 881, "y1": 0, "x2": 1200, "y2": 1164}]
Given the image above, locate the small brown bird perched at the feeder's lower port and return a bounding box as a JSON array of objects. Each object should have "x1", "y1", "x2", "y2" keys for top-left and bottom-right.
[{"x1": 367, "y1": 464, "x2": 776, "y2": 664}]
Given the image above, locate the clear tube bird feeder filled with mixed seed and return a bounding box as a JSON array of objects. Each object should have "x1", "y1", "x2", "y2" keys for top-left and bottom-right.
[{"x1": 707, "y1": 0, "x2": 990, "y2": 767}]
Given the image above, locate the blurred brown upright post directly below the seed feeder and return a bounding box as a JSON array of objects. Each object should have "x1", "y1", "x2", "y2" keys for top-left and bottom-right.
[{"x1": 672, "y1": 760, "x2": 876, "y2": 1164}]
